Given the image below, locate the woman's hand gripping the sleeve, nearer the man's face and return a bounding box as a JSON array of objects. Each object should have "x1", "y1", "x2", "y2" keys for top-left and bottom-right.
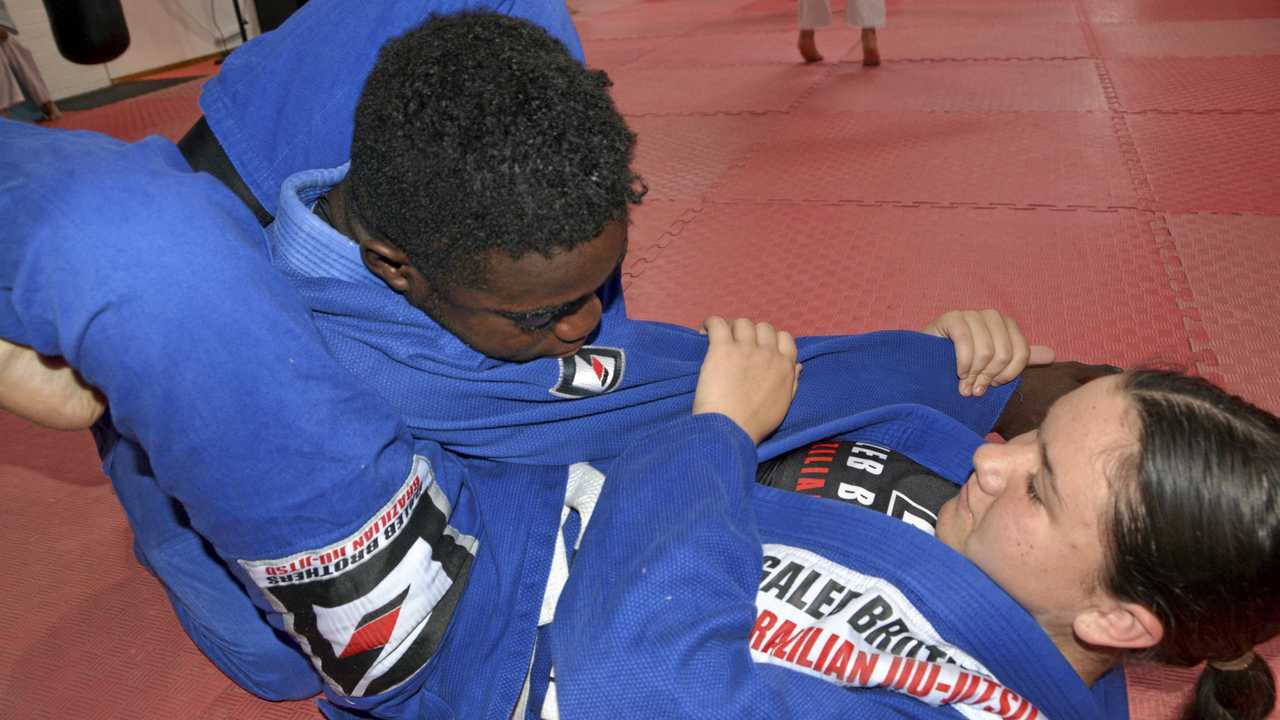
[{"x1": 694, "y1": 315, "x2": 800, "y2": 445}]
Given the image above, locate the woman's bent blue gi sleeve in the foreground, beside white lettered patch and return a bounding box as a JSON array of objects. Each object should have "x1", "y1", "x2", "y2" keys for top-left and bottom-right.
[{"x1": 552, "y1": 415, "x2": 936, "y2": 720}]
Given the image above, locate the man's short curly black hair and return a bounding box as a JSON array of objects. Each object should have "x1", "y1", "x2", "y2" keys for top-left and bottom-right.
[{"x1": 349, "y1": 12, "x2": 644, "y2": 287}]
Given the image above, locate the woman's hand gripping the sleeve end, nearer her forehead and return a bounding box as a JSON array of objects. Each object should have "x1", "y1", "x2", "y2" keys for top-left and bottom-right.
[{"x1": 922, "y1": 310, "x2": 1053, "y2": 397}]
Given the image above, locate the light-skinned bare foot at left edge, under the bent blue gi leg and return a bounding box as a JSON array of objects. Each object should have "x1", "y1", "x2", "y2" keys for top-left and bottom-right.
[{"x1": 0, "y1": 340, "x2": 106, "y2": 430}]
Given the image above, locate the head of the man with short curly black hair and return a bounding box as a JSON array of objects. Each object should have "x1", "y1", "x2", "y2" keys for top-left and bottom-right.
[{"x1": 347, "y1": 13, "x2": 643, "y2": 360}]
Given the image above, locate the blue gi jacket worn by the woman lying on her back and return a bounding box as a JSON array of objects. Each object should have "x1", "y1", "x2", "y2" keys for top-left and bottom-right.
[{"x1": 550, "y1": 405, "x2": 1128, "y2": 720}]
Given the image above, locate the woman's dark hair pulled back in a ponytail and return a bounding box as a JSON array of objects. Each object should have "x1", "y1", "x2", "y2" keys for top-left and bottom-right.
[{"x1": 1103, "y1": 370, "x2": 1280, "y2": 720}]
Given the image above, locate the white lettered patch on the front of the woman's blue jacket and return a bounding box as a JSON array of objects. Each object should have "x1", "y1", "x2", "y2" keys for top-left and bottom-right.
[{"x1": 749, "y1": 544, "x2": 1044, "y2": 720}]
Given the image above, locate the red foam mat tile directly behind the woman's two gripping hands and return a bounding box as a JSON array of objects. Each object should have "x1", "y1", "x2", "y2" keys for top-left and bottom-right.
[{"x1": 627, "y1": 202, "x2": 1192, "y2": 364}]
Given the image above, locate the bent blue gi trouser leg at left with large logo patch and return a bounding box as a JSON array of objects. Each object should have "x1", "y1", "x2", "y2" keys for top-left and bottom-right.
[{"x1": 0, "y1": 123, "x2": 479, "y2": 711}]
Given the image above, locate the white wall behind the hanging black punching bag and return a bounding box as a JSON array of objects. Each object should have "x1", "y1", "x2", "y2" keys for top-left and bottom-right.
[{"x1": 5, "y1": 0, "x2": 257, "y2": 97}]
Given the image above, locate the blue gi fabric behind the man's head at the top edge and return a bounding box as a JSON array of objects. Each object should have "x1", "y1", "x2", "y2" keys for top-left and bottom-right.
[{"x1": 200, "y1": 0, "x2": 582, "y2": 215}]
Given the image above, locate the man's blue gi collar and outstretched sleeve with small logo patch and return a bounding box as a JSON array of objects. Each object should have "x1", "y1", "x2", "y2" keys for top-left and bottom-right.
[{"x1": 266, "y1": 167, "x2": 1016, "y2": 464}]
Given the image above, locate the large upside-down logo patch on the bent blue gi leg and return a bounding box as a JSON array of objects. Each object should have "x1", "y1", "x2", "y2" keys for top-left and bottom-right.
[{"x1": 241, "y1": 456, "x2": 479, "y2": 697}]
